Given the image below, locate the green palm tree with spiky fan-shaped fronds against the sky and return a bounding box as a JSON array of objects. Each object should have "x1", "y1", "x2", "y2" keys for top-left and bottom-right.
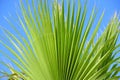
[{"x1": 0, "y1": 0, "x2": 120, "y2": 80}]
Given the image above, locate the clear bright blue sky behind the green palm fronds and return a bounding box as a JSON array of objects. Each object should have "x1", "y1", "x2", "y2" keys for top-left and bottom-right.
[{"x1": 0, "y1": 0, "x2": 120, "y2": 79}]
